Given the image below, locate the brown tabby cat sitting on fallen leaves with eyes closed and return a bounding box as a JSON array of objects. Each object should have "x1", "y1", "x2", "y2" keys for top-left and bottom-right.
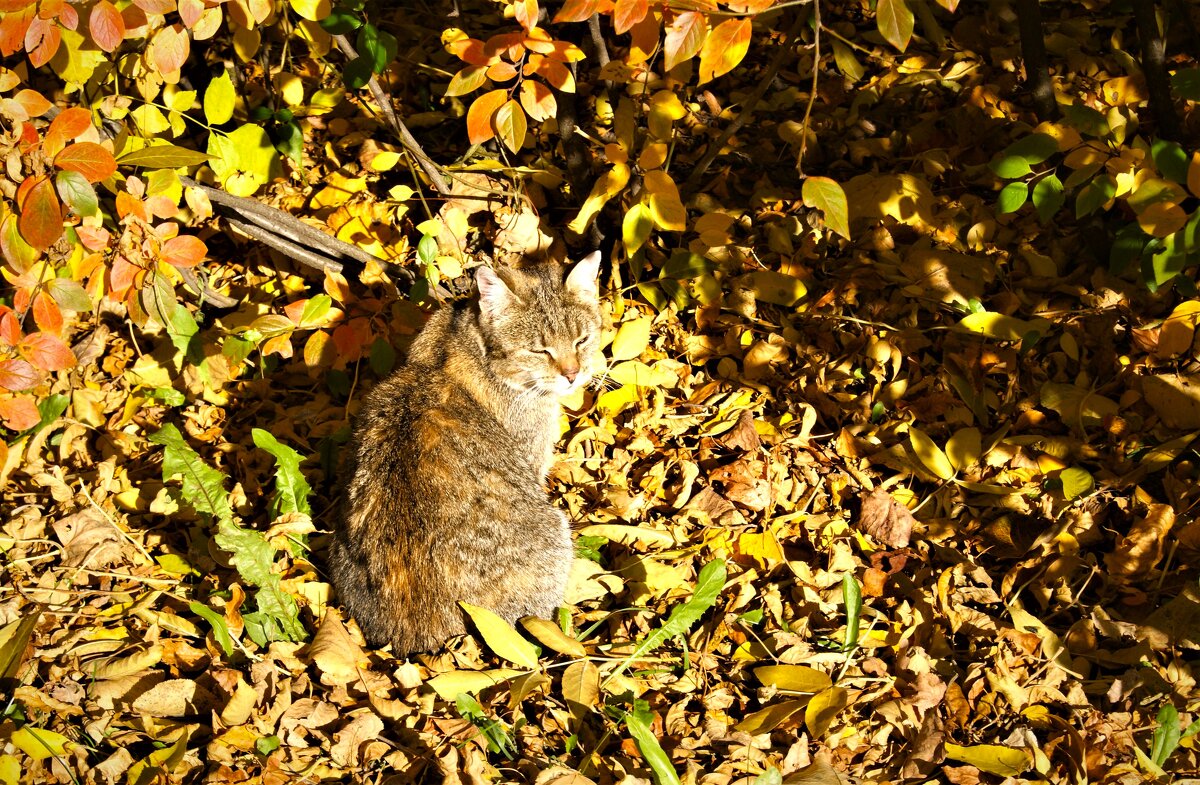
[{"x1": 329, "y1": 252, "x2": 600, "y2": 657}]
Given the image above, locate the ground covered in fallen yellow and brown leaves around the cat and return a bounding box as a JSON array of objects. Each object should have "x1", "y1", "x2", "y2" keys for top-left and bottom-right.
[{"x1": 0, "y1": 1, "x2": 1200, "y2": 785}]
